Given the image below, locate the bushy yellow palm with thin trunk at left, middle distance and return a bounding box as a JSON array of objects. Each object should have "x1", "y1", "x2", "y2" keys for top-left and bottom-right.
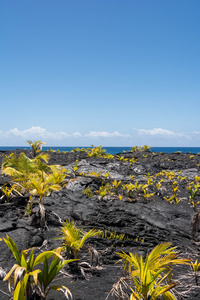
[{"x1": 2, "y1": 153, "x2": 67, "y2": 225}]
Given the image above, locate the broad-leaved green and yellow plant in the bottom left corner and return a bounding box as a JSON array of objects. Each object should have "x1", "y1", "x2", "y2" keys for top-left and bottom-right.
[{"x1": 3, "y1": 236, "x2": 74, "y2": 300}]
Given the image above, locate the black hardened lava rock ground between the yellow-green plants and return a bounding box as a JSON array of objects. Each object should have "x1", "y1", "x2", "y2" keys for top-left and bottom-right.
[{"x1": 0, "y1": 150, "x2": 200, "y2": 300}]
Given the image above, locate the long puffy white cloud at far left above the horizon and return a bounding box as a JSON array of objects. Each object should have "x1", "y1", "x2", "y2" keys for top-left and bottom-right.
[{"x1": 0, "y1": 126, "x2": 81, "y2": 140}]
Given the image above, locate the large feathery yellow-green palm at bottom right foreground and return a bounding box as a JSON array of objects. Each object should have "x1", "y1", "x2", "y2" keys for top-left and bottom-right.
[{"x1": 117, "y1": 243, "x2": 189, "y2": 300}]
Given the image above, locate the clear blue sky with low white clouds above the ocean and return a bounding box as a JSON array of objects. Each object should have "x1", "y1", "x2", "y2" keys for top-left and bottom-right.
[{"x1": 0, "y1": 0, "x2": 200, "y2": 146}]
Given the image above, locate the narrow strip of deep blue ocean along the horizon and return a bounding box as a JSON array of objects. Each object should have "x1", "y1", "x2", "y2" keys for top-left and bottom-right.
[{"x1": 0, "y1": 146, "x2": 200, "y2": 154}]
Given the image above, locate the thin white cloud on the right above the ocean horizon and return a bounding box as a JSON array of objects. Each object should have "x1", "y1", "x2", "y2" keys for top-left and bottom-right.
[{"x1": 135, "y1": 128, "x2": 189, "y2": 138}]
